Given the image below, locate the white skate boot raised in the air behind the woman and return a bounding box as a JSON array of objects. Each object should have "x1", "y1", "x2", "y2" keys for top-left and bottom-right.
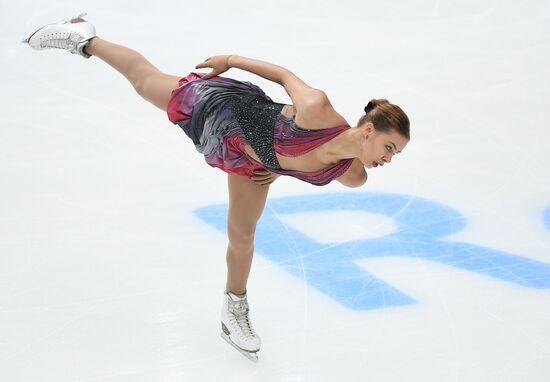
[{"x1": 22, "y1": 13, "x2": 96, "y2": 58}]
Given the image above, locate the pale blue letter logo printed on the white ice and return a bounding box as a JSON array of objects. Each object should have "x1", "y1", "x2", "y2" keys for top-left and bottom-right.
[{"x1": 196, "y1": 192, "x2": 550, "y2": 310}]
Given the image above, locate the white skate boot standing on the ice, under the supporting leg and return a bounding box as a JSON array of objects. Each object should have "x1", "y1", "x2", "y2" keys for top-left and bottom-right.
[{"x1": 221, "y1": 292, "x2": 261, "y2": 362}]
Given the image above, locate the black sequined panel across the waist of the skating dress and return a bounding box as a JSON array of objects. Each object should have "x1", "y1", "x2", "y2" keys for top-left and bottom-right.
[{"x1": 231, "y1": 94, "x2": 284, "y2": 169}]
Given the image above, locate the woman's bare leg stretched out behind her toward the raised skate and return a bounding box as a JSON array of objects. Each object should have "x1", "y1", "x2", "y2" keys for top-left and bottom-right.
[{"x1": 85, "y1": 37, "x2": 181, "y2": 111}]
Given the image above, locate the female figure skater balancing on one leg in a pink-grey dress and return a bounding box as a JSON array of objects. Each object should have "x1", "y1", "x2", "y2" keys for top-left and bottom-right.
[{"x1": 24, "y1": 15, "x2": 410, "y2": 360}]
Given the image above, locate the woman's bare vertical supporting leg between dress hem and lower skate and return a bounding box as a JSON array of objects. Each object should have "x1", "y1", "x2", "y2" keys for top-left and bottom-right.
[{"x1": 226, "y1": 175, "x2": 269, "y2": 294}]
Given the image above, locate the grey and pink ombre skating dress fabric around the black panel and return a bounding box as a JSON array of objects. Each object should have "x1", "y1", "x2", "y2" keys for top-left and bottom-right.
[{"x1": 167, "y1": 73, "x2": 353, "y2": 186}]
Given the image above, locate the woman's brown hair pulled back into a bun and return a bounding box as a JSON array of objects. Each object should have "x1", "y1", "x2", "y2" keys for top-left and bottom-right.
[{"x1": 357, "y1": 99, "x2": 411, "y2": 140}]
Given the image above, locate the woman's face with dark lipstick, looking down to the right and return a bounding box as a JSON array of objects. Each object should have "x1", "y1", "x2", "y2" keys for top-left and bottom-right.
[{"x1": 360, "y1": 122, "x2": 409, "y2": 168}]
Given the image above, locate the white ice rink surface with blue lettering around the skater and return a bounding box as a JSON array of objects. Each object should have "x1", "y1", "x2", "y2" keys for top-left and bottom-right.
[{"x1": 0, "y1": 0, "x2": 550, "y2": 382}]
